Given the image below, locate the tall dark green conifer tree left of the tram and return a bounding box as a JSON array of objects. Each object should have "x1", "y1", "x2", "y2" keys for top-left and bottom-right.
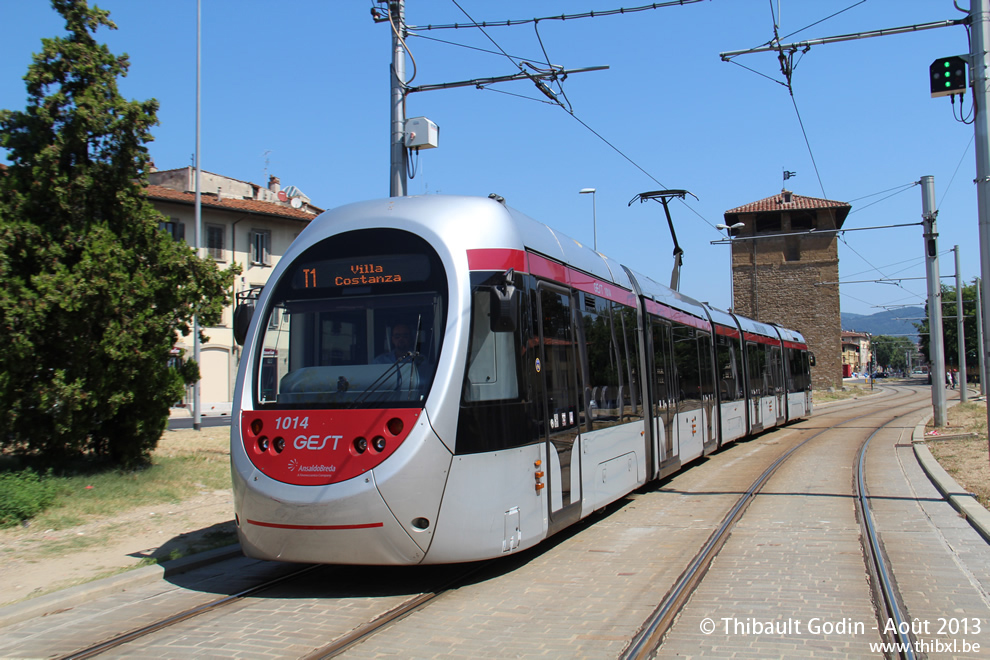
[{"x1": 0, "y1": 0, "x2": 234, "y2": 465}]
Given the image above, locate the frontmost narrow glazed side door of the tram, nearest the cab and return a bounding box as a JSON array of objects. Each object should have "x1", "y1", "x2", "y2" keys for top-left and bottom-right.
[{"x1": 536, "y1": 283, "x2": 583, "y2": 524}]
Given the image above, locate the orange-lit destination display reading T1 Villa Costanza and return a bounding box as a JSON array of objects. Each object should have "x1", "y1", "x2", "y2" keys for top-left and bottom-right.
[{"x1": 292, "y1": 254, "x2": 430, "y2": 290}]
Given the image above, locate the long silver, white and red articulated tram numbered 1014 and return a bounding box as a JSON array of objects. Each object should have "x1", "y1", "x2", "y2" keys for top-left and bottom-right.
[{"x1": 231, "y1": 196, "x2": 813, "y2": 564}]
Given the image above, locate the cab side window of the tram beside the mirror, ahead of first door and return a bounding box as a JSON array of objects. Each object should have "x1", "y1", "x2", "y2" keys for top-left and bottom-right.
[{"x1": 464, "y1": 287, "x2": 519, "y2": 401}]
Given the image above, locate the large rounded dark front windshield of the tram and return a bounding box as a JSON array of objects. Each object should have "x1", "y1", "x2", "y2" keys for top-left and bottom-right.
[{"x1": 255, "y1": 230, "x2": 446, "y2": 408}]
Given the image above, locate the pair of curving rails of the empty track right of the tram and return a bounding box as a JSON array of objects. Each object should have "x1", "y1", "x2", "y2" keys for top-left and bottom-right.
[{"x1": 619, "y1": 384, "x2": 930, "y2": 660}]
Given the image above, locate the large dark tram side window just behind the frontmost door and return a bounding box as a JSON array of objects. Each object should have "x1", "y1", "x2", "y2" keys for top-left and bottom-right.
[{"x1": 578, "y1": 293, "x2": 643, "y2": 430}]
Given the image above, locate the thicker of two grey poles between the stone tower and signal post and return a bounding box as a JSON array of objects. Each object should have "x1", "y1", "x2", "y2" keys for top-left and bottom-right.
[{"x1": 921, "y1": 176, "x2": 945, "y2": 428}]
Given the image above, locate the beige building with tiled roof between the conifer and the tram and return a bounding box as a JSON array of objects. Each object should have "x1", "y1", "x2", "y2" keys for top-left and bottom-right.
[{"x1": 146, "y1": 167, "x2": 323, "y2": 414}]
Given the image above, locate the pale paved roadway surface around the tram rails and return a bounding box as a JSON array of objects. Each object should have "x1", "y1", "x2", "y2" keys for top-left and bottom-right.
[{"x1": 0, "y1": 387, "x2": 990, "y2": 658}]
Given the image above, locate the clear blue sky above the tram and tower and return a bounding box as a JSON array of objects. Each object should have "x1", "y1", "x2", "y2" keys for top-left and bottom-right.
[{"x1": 0, "y1": 0, "x2": 979, "y2": 314}]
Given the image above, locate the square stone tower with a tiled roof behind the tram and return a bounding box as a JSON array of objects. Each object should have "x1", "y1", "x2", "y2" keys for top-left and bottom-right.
[{"x1": 725, "y1": 190, "x2": 852, "y2": 389}]
